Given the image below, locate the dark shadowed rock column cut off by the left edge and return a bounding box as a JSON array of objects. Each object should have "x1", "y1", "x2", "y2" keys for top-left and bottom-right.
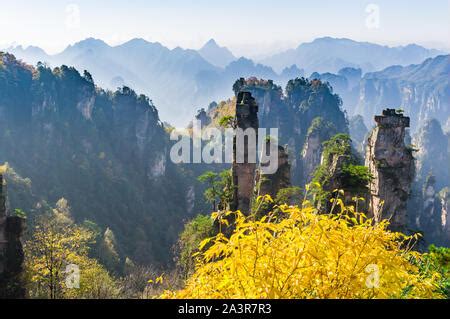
[{"x1": 0, "y1": 174, "x2": 25, "y2": 299}]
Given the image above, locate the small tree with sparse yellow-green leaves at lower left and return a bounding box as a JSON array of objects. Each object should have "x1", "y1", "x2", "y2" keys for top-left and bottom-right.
[{"x1": 24, "y1": 199, "x2": 118, "y2": 299}]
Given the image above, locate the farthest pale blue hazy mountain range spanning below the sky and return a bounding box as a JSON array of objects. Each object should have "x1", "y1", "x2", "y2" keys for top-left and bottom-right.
[{"x1": 6, "y1": 38, "x2": 441, "y2": 125}]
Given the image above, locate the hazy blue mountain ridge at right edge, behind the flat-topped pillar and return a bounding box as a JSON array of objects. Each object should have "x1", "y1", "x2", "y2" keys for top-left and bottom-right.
[{"x1": 310, "y1": 55, "x2": 450, "y2": 132}]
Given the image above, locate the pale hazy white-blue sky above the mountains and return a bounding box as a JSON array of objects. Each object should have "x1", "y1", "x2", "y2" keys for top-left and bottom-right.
[{"x1": 0, "y1": 0, "x2": 450, "y2": 56}]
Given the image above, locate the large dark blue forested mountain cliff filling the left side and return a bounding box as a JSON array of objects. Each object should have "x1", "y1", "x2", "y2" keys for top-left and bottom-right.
[{"x1": 0, "y1": 54, "x2": 189, "y2": 264}]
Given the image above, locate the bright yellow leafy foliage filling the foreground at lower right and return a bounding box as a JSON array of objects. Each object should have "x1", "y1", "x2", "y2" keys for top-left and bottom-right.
[{"x1": 161, "y1": 199, "x2": 442, "y2": 299}]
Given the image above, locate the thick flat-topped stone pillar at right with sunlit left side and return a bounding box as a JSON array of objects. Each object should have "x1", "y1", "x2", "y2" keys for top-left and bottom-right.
[{"x1": 366, "y1": 109, "x2": 414, "y2": 230}]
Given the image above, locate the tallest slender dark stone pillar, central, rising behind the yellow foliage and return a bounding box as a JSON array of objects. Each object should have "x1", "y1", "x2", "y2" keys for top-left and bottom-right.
[{"x1": 231, "y1": 92, "x2": 259, "y2": 214}]
